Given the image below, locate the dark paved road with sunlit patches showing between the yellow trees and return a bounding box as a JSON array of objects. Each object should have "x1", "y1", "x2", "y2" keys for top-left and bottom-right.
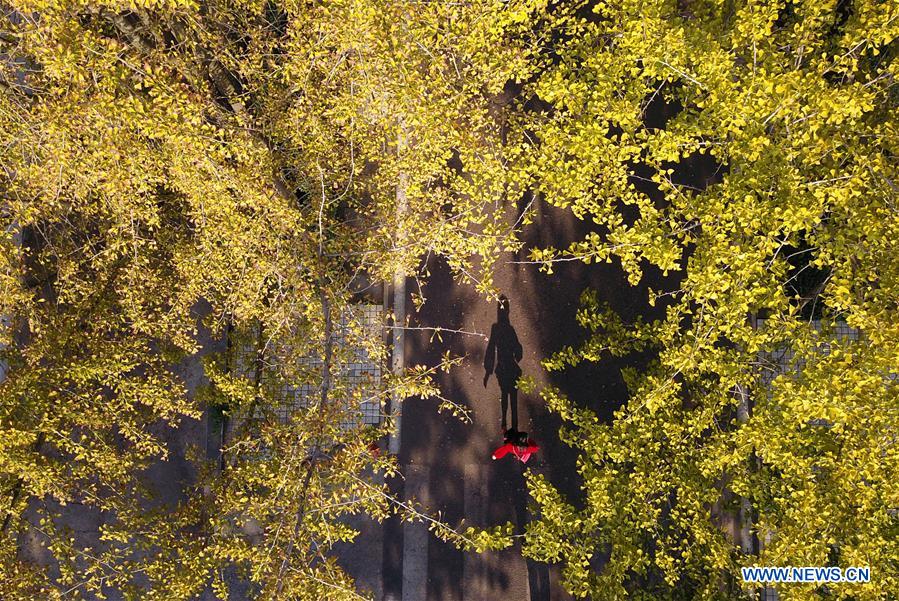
[{"x1": 366, "y1": 198, "x2": 676, "y2": 601}]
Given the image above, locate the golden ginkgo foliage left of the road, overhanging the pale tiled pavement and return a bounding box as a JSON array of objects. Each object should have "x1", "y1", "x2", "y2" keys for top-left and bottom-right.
[{"x1": 0, "y1": 0, "x2": 546, "y2": 600}]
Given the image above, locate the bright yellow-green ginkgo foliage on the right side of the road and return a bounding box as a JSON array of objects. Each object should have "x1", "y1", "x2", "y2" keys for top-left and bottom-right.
[{"x1": 525, "y1": 0, "x2": 899, "y2": 600}]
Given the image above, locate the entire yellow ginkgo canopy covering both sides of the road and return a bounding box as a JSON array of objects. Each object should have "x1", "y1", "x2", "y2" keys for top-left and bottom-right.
[{"x1": 0, "y1": 0, "x2": 899, "y2": 600}]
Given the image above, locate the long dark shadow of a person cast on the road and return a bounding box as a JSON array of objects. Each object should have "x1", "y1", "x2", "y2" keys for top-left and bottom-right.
[{"x1": 484, "y1": 296, "x2": 523, "y2": 432}]
